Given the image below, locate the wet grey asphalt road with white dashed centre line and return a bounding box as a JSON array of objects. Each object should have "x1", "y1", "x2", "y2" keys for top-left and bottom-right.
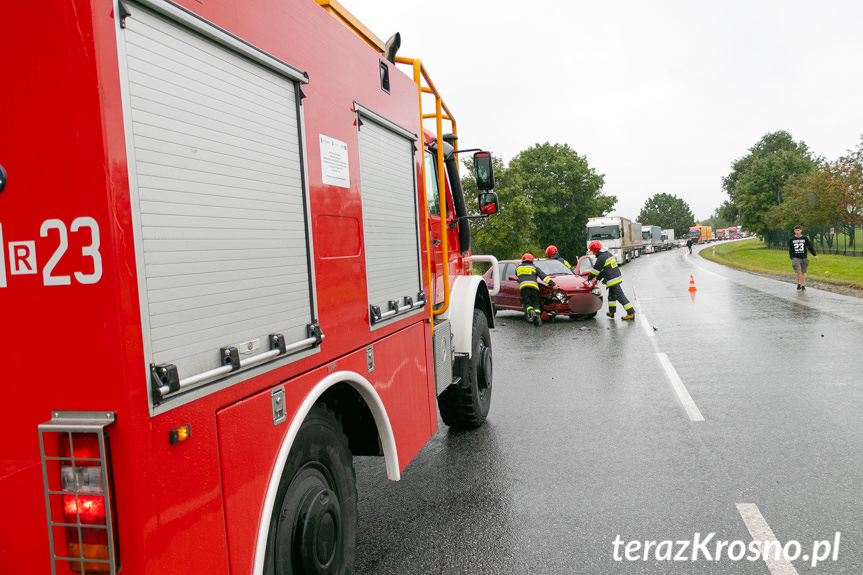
[{"x1": 355, "y1": 246, "x2": 863, "y2": 575}]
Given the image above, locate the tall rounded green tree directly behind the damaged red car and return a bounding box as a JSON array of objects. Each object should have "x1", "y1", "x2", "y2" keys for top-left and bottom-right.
[{"x1": 509, "y1": 142, "x2": 617, "y2": 258}]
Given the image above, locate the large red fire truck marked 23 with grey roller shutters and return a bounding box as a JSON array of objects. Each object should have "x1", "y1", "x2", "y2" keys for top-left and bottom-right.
[{"x1": 0, "y1": 0, "x2": 498, "y2": 575}]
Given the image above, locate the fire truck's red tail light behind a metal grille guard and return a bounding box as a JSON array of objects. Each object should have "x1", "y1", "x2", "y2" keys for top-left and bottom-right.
[{"x1": 39, "y1": 412, "x2": 119, "y2": 575}]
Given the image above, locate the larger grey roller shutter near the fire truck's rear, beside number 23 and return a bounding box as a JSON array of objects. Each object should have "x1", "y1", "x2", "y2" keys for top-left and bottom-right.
[{"x1": 118, "y1": 0, "x2": 316, "y2": 410}]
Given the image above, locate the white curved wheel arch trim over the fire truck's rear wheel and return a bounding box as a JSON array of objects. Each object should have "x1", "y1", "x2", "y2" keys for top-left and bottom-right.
[{"x1": 253, "y1": 371, "x2": 401, "y2": 575}]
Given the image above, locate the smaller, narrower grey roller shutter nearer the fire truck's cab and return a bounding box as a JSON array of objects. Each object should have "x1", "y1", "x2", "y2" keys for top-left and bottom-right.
[{"x1": 355, "y1": 104, "x2": 425, "y2": 329}]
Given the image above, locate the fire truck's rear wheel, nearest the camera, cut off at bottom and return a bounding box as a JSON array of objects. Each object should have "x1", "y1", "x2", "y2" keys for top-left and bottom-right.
[{"x1": 264, "y1": 404, "x2": 357, "y2": 575}]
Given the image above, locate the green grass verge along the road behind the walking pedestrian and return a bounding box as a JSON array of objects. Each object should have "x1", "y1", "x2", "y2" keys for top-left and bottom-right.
[{"x1": 700, "y1": 238, "x2": 863, "y2": 288}]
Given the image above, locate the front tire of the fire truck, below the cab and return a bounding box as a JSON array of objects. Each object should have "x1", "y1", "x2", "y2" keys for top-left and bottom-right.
[{"x1": 438, "y1": 309, "x2": 492, "y2": 429}]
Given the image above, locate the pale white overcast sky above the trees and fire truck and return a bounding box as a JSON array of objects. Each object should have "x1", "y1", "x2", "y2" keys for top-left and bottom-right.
[{"x1": 340, "y1": 0, "x2": 863, "y2": 223}]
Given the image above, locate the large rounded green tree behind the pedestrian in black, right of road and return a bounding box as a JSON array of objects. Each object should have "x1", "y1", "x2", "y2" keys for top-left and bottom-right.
[{"x1": 722, "y1": 130, "x2": 821, "y2": 233}]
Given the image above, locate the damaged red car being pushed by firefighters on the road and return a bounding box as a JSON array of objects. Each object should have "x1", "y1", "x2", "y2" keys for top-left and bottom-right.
[{"x1": 482, "y1": 256, "x2": 602, "y2": 321}]
